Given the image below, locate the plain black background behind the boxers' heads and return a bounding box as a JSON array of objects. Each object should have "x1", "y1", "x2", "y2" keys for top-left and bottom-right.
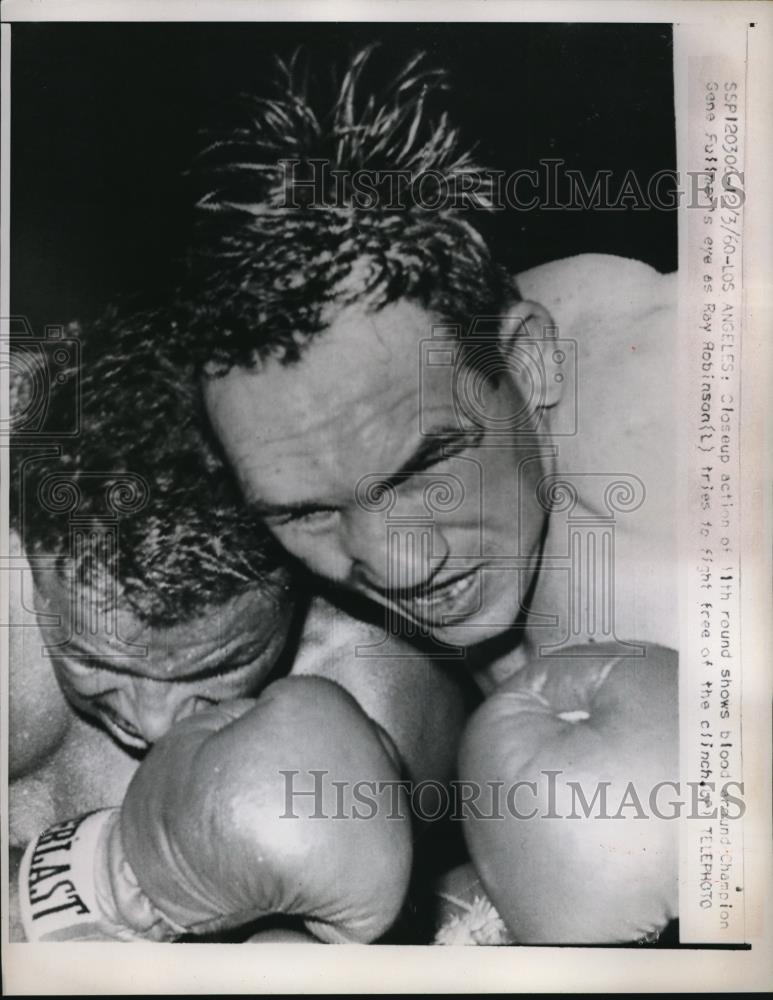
[{"x1": 11, "y1": 23, "x2": 676, "y2": 333}]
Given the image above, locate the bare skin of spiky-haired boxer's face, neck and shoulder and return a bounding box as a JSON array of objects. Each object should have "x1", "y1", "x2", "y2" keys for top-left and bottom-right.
[{"x1": 204, "y1": 254, "x2": 677, "y2": 691}]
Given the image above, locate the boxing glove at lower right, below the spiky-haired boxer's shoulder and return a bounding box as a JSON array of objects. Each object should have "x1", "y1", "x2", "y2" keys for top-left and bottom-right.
[{"x1": 460, "y1": 644, "x2": 679, "y2": 944}]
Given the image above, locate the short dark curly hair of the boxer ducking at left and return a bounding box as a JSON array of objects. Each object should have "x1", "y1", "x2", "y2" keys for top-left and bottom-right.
[{"x1": 11, "y1": 309, "x2": 288, "y2": 626}]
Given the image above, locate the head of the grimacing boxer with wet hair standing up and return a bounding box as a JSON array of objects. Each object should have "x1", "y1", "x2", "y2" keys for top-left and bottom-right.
[{"x1": 185, "y1": 51, "x2": 560, "y2": 645}]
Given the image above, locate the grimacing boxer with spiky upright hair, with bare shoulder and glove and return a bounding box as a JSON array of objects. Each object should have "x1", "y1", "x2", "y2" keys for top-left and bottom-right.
[{"x1": 185, "y1": 50, "x2": 678, "y2": 943}]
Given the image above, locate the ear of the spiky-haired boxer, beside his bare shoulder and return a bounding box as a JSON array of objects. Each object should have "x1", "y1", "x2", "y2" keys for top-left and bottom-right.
[{"x1": 499, "y1": 299, "x2": 564, "y2": 409}]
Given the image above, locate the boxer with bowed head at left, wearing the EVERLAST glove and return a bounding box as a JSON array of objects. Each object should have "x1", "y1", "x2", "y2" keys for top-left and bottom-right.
[{"x1": 9, "y1": 302, "x2": 464, "y2": 940}]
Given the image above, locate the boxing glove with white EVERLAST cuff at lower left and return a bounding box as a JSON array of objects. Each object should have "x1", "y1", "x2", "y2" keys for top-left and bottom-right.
[{"x1": 20, "y1": 677, "x2": 412, "y2": 942}]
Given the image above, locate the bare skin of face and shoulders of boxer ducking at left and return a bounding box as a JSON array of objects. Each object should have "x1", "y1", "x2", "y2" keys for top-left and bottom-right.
[{"x1": 9, "y1": 535, "x2": 466, "y2": 847}]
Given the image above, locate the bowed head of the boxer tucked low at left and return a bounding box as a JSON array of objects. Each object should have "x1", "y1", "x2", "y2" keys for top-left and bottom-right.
[{"x1": 12, "y1": 312, "x2": 293, "y2": 751}]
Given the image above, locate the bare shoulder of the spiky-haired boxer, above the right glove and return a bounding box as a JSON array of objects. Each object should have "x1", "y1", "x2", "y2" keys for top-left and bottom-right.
[{"x1": 510, "y1": 254, "x2": 678, "y2": 648}]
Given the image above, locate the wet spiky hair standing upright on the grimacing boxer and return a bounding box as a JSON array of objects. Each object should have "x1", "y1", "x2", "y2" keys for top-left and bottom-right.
[{"x1": 181, "y1": 46, "x2": 516, "y2": 372}]
